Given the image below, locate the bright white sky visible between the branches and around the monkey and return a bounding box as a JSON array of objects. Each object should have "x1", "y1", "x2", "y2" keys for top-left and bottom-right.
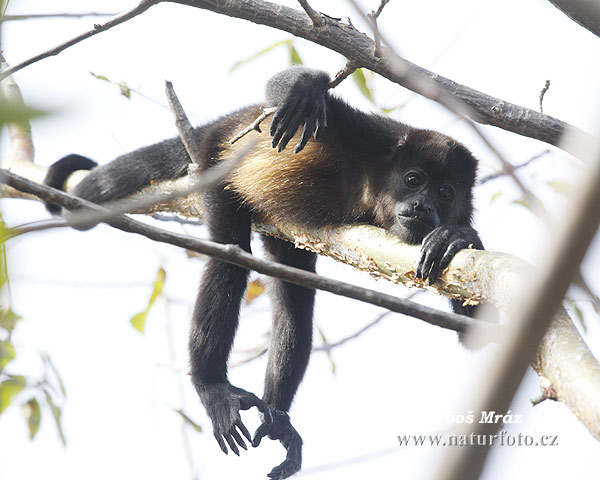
[{"x1": 0, "y1": 0, "x2": 600, "y2": 480}]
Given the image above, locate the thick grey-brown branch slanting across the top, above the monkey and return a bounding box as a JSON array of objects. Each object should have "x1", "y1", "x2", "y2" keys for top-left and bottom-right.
[{"x1": 168, "y1": 0, "x2": 590, "y2": 147}]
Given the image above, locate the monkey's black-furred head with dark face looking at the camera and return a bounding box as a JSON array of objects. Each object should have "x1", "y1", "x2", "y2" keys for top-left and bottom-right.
[{"x1": 389, "y1": 129, "x2": 477, "y2": 244}]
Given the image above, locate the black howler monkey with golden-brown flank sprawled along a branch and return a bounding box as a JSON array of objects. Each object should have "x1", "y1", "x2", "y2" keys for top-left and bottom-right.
[{"x1": 47, "y1": 67, "x2": 483, "y2": 478}]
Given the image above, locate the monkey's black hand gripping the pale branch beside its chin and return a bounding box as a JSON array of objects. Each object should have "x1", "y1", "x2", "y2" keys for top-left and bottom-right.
[{"x1": 415, "y1": 225, "x2": 483, "y2": 285}]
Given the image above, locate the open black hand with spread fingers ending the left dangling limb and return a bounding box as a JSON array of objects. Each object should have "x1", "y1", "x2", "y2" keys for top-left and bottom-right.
[{"x1": 196, "y1": 383, "x2": 273, "y2": 455}]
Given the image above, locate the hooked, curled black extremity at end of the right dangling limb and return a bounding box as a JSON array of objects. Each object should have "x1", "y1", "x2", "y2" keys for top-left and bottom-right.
[{"x1": 252, "y1": 410, "x2": 302, "y2": 479}]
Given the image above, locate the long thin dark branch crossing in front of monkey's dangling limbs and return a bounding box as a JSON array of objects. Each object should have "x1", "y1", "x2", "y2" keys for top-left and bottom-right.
[{"x1": 0, "y1": 170, "x2": 500, "y2": 333}]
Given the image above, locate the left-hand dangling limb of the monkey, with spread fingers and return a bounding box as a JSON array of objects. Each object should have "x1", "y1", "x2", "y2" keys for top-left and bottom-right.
[{"x1": 189, "y1": 186, "x2": 271, "y2": 455}]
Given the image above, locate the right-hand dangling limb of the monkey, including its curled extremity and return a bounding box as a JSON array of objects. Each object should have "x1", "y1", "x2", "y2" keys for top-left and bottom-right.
[{"x1": 253, "y1": 237, "x2": 316, "y2": 478}]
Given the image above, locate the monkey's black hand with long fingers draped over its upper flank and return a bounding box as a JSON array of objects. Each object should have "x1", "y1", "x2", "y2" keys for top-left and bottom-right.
[{"x1": 270, "y1": 69, "x2": 329, "y2": 153}]
